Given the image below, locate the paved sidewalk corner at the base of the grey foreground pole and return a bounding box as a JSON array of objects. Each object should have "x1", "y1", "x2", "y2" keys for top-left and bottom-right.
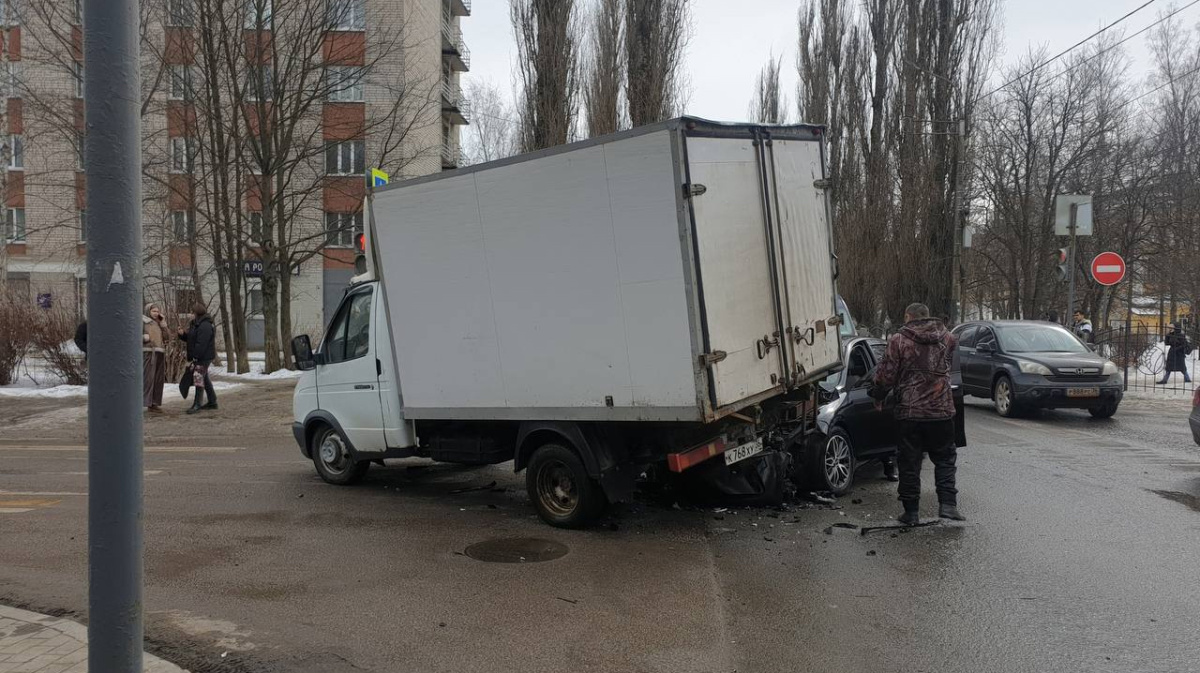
[{"x1": 0, "y1": 606, "x2": 186, "y2": 673}]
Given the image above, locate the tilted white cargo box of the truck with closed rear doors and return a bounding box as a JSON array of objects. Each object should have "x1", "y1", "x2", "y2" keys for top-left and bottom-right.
[{"x1": 370, "y1": 118, "x2": 840, "y2": 422}]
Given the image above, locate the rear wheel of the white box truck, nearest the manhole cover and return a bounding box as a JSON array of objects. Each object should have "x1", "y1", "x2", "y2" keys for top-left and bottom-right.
[{"x1": 526, "y1": 444, "x2": 607, "y2": 528}]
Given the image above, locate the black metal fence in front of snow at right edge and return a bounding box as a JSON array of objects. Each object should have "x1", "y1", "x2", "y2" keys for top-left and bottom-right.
[{"x1": 1096, "y1": 325, "x2": 1200, "y2": 393}]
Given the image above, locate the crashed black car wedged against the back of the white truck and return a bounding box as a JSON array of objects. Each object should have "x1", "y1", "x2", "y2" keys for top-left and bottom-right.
[{"x1": 800, "y1": 337, "x2": 966, "y2": 495}]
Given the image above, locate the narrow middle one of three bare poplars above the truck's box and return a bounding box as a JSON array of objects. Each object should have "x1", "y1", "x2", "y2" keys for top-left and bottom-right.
[{"x1": 583, "y1": 0, "x2": 625, "y2": 138}]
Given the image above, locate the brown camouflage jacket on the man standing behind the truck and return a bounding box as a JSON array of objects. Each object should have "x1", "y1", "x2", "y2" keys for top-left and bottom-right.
[{"x1": 871, "y1": 318, "x2": 959, "y2": 421}]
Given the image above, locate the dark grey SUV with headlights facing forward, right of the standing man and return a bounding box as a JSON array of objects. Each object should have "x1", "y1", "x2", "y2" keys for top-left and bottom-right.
[{"x1": 954, "y1": 320, "x2": 1123, "y2": 419}]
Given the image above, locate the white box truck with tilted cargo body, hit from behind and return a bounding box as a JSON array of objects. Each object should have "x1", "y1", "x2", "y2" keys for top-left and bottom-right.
[{"x1": 292, "y1": 118, "x2": 841, "y2": 527}]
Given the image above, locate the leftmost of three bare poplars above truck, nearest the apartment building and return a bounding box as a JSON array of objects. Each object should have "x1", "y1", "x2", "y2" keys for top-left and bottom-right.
[{"x1": 509, "y1": 0, "x2": 581, "y2": 151}]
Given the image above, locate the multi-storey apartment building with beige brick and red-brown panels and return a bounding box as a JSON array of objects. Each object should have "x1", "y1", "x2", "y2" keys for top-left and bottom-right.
[{"x1": 0, "y1": 0, "x2": 470, "y2": 349}]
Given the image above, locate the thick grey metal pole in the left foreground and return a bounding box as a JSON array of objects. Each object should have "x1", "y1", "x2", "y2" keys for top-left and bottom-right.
[{"x1": 84, "y1": 0, "x2": 143, "y2": 673}]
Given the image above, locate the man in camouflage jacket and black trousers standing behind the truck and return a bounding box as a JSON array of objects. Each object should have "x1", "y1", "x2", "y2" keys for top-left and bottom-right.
[{"x1": 871, "y1": 304, "x2": 965, "y2": 525}]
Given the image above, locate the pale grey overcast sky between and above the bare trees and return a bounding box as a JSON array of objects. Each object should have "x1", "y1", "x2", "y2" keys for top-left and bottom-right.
[{"x1": 463, "y1": 0, "x2": 1180, "y2": 121}]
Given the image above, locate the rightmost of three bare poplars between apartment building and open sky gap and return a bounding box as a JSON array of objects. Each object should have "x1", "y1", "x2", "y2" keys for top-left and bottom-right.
[{"x1": 625, "y1": 0, "x2": 691, "y2": 126}]
